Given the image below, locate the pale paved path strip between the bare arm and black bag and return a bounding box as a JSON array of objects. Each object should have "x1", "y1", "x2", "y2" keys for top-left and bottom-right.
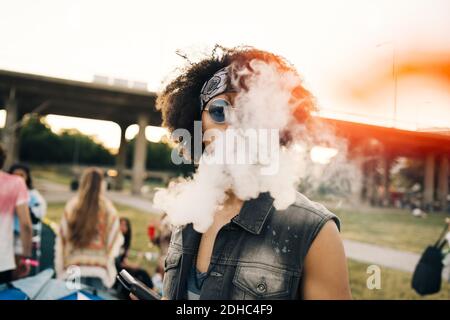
[{"x1": 344, "y1": 240, "x2": 420, "y2": 272}]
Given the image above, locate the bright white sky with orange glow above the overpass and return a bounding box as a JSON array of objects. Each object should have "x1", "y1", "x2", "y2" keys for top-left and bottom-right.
[{"x1": 0, "y1": 0, "x2": 450, "y2": 149}]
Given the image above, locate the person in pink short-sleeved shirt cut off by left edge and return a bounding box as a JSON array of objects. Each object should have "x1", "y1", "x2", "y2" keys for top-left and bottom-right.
[{"x1": 0, "y1": 146, "x2": 32, "y2": 283}]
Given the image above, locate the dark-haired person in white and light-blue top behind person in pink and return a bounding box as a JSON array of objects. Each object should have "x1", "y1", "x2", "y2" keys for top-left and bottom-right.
[{"x1": 9, "y1": 164, "x2": 47, "y2": 276}]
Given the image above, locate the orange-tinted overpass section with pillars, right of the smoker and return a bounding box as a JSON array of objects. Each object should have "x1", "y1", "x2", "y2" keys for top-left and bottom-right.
[{"x1": 322, "y1": 119, "x2": 450, "y2": 209}]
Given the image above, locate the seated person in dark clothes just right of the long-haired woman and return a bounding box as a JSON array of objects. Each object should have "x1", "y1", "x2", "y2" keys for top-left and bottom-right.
[{"x1": 116, "y1": 218, "x2": 153, "y2": 296}]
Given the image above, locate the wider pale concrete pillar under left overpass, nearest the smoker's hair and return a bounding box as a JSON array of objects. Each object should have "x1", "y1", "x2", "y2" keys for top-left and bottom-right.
[{"x1": 131, "y1": 114, "x2": 148, "y2": 194}]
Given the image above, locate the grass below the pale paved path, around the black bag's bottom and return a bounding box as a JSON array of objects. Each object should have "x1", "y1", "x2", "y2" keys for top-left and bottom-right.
[{"x1": 348, "y1": 260, "x2": 450, "y2": 300}]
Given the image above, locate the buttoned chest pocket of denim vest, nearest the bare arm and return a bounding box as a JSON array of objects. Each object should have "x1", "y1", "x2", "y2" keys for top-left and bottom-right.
[{"x1": 233, "y1": 263, "x2": 294, "y2": 299}]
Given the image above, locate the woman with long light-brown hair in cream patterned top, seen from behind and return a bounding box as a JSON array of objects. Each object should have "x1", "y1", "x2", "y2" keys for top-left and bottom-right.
[{"x1": 55, "y1": 168, "x2": 123, "y2": 290}]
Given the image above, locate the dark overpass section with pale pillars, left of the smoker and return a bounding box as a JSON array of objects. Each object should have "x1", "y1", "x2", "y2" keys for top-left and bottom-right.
[{"x1": 0, "y1": 70, "x2": 161, "y2": 193}]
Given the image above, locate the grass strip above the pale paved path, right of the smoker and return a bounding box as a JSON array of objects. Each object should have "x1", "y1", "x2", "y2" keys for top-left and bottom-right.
[{"x1": 330, "y1": 208, "x2": 449, "y2": 253}]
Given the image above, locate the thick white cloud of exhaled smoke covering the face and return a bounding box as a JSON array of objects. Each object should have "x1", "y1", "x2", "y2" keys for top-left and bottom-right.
[{"x1": 154, "y1": 60, "x2": 356, "y2": 232}]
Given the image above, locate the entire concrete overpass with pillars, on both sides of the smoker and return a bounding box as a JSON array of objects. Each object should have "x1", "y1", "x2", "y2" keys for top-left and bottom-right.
[{"x1": 0, "y1": 70, "x2": 450, "y2": 205}]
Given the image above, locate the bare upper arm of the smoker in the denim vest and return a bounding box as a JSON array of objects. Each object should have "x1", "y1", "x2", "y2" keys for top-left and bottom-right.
[{"x1": 300, "y1": 221, "x2": 352, "y2": 300}]
